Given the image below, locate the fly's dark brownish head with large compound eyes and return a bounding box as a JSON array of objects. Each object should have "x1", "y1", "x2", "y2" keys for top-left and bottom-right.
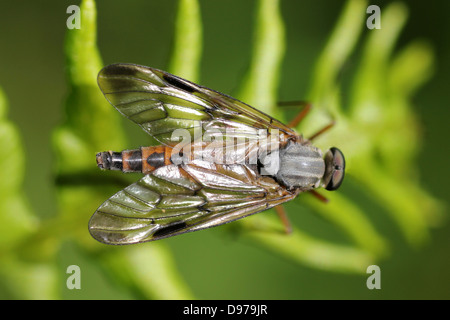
[{"x1": 323, "y1": 147, "x2": 345, "y2": 191}]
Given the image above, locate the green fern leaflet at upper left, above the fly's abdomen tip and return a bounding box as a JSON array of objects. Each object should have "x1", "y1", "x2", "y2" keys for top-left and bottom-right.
[{"x1": 53, "y1": 0, "x2": 125, "y2": 173}]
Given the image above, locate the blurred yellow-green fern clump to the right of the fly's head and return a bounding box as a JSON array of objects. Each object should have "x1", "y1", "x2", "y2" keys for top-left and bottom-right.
[{"x1": 347, "y1": 3, "x2": 442, "y2": 245}]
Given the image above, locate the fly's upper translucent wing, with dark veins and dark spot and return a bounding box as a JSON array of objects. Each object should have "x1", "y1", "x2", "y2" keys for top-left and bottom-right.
[{"x1": 98, "y1": 64, "x2": 296, "y2": 146}]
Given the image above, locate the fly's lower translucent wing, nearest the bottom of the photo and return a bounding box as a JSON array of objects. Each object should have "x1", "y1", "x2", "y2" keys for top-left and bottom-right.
[{"x1": 89, "y1": 161, "x2": 296, "y2": 244}]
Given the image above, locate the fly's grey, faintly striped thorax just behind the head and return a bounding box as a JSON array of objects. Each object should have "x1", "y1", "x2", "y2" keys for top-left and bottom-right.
[{"x1": 275, "y1": 141, "x2": 325, "y2": 190}]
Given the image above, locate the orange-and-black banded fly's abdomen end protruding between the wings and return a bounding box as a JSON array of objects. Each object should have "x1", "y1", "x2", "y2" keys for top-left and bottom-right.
[{"x1": 97, "y1": 146, "x2": 172, "y2": 173}]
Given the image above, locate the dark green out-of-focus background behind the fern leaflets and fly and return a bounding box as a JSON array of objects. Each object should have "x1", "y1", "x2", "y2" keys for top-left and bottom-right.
[{"x1": 0, "y1": 0, "x2": 450, "y2": 299}]
